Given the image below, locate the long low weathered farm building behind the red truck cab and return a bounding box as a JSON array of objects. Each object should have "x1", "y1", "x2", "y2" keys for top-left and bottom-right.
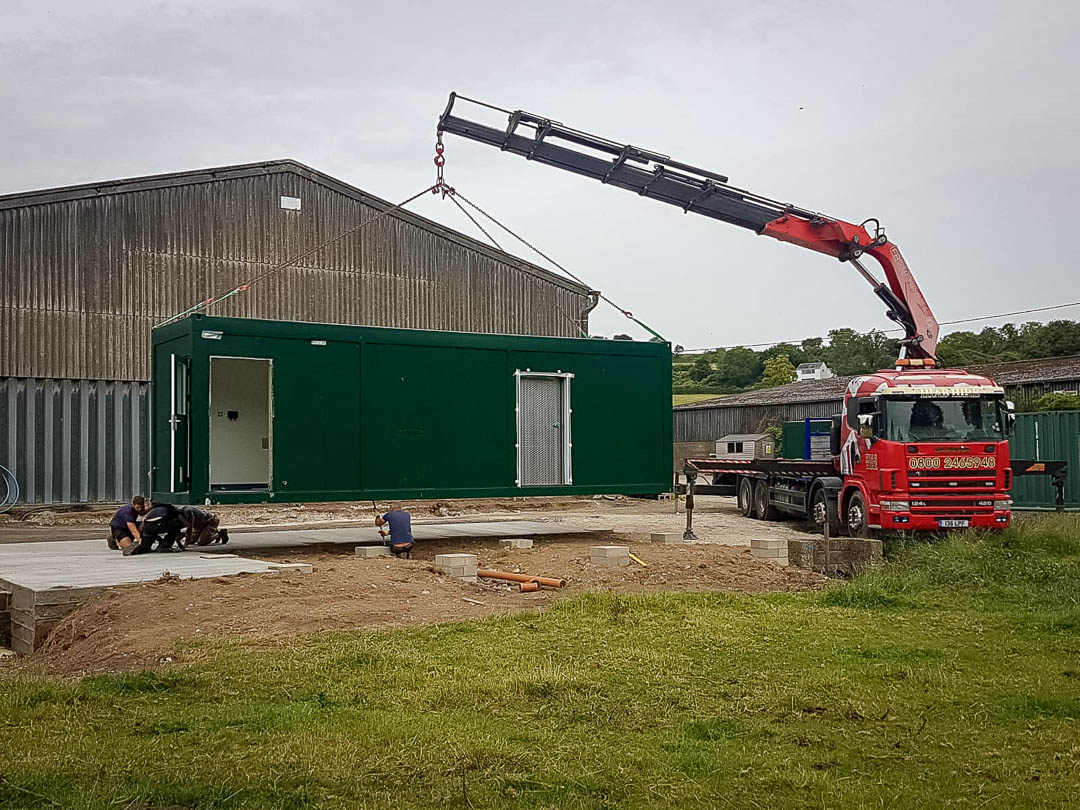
[{"x1": 674, "y1": 355, "x2": 1080, "y2": 443}]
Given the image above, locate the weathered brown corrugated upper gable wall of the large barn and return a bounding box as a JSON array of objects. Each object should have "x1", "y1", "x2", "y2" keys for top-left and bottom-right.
[{"x1": 0, "y1": 164, "x2": 589, "y2": 380}]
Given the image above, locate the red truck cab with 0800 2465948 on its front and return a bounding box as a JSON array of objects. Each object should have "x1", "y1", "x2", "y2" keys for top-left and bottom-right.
[{"x1": 833, "y1": 361, "x2": 1012, "y2": 536}]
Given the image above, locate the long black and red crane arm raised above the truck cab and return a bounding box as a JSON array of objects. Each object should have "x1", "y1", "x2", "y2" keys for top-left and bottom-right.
[{"x1": 438, "y1": 93, "x2": 937, "y2": 360}]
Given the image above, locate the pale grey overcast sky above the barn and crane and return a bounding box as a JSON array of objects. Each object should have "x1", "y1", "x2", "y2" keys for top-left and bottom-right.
[{"x1": 0, "y1": 0, "x2": 1080, "y2": 348}]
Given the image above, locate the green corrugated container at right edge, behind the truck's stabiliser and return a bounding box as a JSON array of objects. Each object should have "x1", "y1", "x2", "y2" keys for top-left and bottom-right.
[{"x1": 1009, "y1": 410, "x2": 1080, "y2": 509}]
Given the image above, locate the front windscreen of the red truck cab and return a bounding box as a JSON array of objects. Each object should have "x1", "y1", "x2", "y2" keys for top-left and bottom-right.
[{"x1": 880, "y1": 396, "x2": 1004, "y2": 442}]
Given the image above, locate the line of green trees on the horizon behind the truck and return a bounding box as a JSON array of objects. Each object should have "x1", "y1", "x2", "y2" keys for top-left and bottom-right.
[{"x1": 652, "y1": 321, "x2": 1080, "y2": 394}]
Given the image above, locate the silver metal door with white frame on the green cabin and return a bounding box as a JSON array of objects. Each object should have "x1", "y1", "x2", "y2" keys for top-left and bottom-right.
[{"x1": 517, "y1": 374, "x2": 569, "y2": 487}]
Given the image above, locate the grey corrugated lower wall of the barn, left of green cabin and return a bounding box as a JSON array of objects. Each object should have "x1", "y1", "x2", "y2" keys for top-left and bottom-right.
[{"x1": 0, "y1": 378, "x2": 150, "y2": 503}]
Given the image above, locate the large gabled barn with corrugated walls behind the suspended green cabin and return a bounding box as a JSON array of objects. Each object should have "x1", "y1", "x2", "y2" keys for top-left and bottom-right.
[{"x1": 0, "y1": 160, "x2": 596, "y2": 502}]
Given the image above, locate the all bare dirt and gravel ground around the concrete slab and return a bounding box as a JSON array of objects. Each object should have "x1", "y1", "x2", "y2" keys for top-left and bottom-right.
[{"x1": 0, "y1": 498, "x2": 825, "y2": 676}]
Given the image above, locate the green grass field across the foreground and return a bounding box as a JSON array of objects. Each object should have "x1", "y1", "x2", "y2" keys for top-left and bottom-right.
[{"x1": 0, "y1": 516, "x2": 1080, "y2": 809}]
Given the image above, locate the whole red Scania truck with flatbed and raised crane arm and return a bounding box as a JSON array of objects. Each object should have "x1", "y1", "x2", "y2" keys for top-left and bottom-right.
[{"x1": 438, "y1": 93, "x2": 1061, "y2": 537}]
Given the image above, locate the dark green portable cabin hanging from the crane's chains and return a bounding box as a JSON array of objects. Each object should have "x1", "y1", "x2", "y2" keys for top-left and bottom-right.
[{"x1": 151, "y1": 315, "x2": 672, "y2": 503}]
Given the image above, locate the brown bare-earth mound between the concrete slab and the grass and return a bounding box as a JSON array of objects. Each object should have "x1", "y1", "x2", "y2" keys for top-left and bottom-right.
[{"x1": 12, "y1": 537, "x2": 825, "y2": 675}]
